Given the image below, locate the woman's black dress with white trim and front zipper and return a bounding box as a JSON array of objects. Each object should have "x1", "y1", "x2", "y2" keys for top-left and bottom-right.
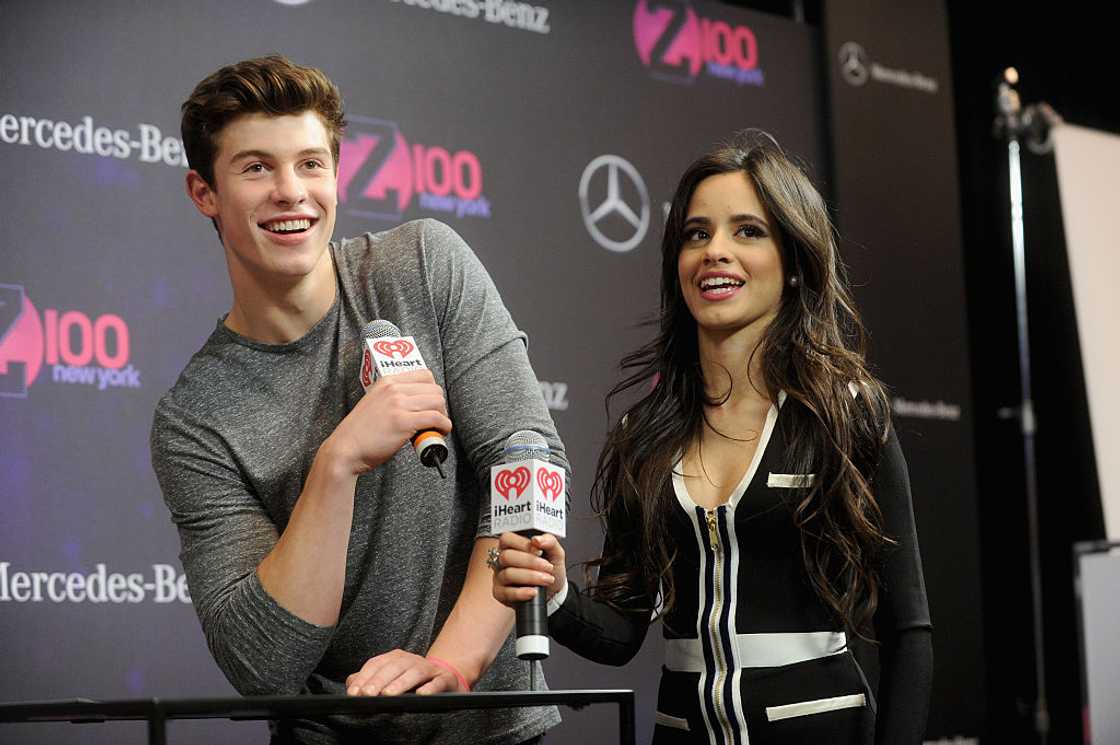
[{"x1": 549, "y1": 394, "x2": 932, "y2": 745}]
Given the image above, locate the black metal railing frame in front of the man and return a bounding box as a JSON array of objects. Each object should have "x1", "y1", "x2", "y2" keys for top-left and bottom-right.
[{"x1": 0, "y1": 689, "x2": 635, "y2": 745}]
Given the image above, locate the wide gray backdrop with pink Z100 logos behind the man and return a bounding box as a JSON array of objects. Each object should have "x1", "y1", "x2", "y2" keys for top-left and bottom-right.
[{"x1": 0, "y1": 0, "x2": 971, "y2": 744}]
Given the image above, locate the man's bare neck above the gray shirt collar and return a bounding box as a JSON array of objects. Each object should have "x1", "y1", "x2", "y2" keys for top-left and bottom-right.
[{"x1": 224, "y1": 251, "x2": 338, "y2": 344}]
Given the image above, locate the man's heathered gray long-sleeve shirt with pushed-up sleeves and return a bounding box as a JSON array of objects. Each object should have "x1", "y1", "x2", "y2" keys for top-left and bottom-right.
[{"x1": 151, "y1": 221, "x2": 567, "y2": 745}]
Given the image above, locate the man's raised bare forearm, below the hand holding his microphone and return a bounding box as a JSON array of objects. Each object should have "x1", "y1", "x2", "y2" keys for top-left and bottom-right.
[{"x1": 256, "y1": 440, "x2": 357, "y2": 626}]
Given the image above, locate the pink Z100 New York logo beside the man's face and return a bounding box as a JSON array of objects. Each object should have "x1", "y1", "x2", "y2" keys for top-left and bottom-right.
[{"x1": 338, "y1": 117, "x2": 491, "y2": 220}]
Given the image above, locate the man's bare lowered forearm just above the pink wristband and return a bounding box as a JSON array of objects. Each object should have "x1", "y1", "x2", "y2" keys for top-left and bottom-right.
[{"x1": 428, "y1": 538, "x2": 513, "y2": 686}]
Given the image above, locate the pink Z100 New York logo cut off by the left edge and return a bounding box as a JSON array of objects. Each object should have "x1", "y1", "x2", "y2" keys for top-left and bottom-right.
[{"x1": 0, "y1": 285, "x2": 140, "y2": 399}]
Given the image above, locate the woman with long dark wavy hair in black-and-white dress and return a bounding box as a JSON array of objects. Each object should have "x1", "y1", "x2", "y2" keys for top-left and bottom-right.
[{"x1": 492, "y1": 131, "x2": 932, "y2": 745}]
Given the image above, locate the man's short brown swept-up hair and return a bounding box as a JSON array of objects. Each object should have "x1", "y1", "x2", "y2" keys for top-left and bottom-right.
[{"x1": 181, "y1": 55, "x2": 346, "y2": 188}]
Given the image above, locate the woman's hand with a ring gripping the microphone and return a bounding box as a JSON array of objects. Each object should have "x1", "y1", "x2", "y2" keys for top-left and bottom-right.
[{"x1": 494, "y1": 533, "x2": 568, "y2": 607}]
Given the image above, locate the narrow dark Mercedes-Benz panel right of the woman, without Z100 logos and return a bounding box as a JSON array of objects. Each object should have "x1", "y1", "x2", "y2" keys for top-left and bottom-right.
[{"x1": 823, "y1": 0, "x2": 981, "y2": 745}]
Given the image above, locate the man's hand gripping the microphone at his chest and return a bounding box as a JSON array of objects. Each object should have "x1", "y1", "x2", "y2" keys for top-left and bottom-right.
[{"x1": 320, "y1": 370, "x2": 451, "y2": 475}]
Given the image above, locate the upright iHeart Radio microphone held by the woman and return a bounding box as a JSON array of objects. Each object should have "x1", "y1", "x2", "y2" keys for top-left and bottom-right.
[{"x1": 491, "y1": 429, "x2": 567, "y2": 660}]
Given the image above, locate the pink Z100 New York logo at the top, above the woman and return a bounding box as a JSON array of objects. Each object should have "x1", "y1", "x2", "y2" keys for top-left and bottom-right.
[{"x1": 634, "y1": 0, "x2": 765, "y2": 85}]
